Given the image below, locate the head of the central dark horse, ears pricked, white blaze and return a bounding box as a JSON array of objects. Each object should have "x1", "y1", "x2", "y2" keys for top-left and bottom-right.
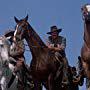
[{"x1": 14, "y1": 15, "x2": 29, "y2": 40}]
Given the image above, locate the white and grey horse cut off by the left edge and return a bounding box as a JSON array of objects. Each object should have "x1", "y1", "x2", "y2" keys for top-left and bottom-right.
[{"x1": 0, "y1": 36, "x2": 13, "y2": 90}]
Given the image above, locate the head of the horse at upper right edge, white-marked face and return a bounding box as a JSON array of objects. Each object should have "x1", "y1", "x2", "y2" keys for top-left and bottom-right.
[{"x1": 81, "y1": 4, "x2": 90, "y2": 21}]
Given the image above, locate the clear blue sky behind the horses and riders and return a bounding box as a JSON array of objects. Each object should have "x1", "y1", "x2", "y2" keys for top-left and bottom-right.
[{"x1": 0, "y1": 0, "x2": 90, "y2": 90}]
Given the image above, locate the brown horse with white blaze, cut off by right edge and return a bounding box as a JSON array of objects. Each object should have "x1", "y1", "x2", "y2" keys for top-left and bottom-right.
[{"x1": 81, "y1": 4, "x2": 90, "y2": 79}]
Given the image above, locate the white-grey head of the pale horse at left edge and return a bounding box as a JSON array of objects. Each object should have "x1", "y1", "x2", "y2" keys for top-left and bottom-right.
[{"x1": 0, "y1": 36, "x2": 10, "y2": 61}]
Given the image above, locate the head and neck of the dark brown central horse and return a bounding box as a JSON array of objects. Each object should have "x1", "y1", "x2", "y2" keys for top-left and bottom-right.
[{"x1": 13, "y1": 15, "x2": 46, "y2": 50}]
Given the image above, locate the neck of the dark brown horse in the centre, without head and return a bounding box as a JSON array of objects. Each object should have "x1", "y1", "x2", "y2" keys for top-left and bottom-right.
[{"x1": 25, "y1": 26, "x2": 46, "y2": 53}]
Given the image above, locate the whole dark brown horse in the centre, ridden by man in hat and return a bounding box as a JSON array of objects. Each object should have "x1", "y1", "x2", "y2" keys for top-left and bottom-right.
[{"x1": 14, "y1": 15, "x2": 67, "y2": 90}]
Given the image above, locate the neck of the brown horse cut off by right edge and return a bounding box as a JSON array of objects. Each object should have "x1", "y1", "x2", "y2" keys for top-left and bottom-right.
[{"x1": 84, "y1": 21, "x2": 90, "y2": 48}]
